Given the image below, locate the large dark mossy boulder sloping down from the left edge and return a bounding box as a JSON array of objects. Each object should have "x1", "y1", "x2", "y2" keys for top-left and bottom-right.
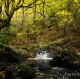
[{"x1": 0, "y1": 44, "x2": 24, "y2": 63}]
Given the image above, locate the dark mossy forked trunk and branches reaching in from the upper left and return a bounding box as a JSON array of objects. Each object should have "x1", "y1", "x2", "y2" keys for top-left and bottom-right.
[{"x1": 0, "y1": 0, "x2": 39, "y2": 30}]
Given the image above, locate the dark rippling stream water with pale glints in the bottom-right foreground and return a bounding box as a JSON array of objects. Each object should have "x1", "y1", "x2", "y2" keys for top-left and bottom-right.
[{"x1": 35, "y1": 67, "x2": 80, "y2": 79}]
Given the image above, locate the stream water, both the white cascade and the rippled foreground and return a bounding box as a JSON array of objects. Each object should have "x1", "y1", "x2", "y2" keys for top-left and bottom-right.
[{"x1": 29, "y1": 51, "x2": 80, "y2": 79}]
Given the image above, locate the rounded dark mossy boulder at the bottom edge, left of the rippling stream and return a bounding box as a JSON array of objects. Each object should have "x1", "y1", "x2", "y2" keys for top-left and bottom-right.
[{"x1": 18, "y1": 64, "x2": 34, "y2": 79}]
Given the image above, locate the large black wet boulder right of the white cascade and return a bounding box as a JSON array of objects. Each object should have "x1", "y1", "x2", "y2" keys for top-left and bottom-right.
[{"x1": 49, "y1": 50, "x2": 80, "y2": 69}]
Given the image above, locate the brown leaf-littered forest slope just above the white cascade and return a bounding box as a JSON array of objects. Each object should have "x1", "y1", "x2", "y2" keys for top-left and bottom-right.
[{"x1": 10, "y1": 28, "x2": 80, "y2": 57}]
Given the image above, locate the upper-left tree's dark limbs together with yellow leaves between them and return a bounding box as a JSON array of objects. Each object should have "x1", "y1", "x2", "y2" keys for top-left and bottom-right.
[{"x1": 0, "y1": 0, "x2": 36, "y2": 30}]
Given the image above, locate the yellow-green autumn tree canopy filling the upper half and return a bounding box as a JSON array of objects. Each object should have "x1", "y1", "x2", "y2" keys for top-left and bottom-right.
[{"x1": 0, "y1": 0, "x2": 80, "y2": 46}]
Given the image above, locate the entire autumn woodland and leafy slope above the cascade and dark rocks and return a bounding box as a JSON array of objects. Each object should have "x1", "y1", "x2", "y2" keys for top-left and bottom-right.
[{"x1": 0, "y1": 0, "x2": 80, "y2": 79}]
